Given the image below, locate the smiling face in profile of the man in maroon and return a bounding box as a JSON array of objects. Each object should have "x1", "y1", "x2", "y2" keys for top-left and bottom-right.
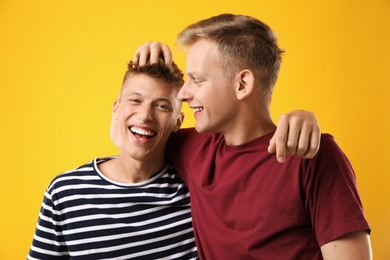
[{"x1": 178, "y1": 40, "x2": 237, "y2": 136}]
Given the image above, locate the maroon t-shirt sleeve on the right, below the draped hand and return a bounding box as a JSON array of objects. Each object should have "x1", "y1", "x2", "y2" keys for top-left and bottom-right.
[{"x1": 306, "y1": 135, "x2": 370, "y2": 246}]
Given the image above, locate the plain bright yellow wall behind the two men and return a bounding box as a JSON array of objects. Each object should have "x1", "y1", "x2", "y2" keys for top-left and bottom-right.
[{"x1": 0, "y1": 0, "x2": 390, "y2": 260}]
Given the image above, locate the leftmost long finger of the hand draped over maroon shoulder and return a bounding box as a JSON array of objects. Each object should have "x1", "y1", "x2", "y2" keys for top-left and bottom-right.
[{"x1": 274, "y1": 114, "x2": 289, "y2": 163}]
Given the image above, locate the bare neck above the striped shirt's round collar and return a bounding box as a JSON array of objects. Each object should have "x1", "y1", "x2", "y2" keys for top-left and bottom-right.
[{"x1": 98, "y1": 155, "x2": 166, "y2": 183}]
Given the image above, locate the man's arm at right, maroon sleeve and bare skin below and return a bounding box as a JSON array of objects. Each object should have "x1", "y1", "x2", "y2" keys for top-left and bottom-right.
[{"x1": 305, "y1": 135, "x2": 372, "y2": 260}]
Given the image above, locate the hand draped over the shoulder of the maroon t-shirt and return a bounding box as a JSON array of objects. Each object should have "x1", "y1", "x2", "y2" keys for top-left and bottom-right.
[{"x1": 268, "y1": 110, "x2": 321, "y2": 163}]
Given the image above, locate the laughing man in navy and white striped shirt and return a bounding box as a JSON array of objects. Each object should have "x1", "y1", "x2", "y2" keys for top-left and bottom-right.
[{"x1": 27, "y1": 64, "x2": 197, "y2": 260}]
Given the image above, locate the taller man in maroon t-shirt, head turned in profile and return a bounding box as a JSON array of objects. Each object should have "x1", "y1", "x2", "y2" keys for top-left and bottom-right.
[{"x1": 136, "y1": 14, "x2": 371, "y2": 259}]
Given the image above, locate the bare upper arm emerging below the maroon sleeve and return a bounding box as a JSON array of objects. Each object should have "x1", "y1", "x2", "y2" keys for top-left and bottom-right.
[{"x1": 321, "y1": 231, "x2": 372, "y2": 260}]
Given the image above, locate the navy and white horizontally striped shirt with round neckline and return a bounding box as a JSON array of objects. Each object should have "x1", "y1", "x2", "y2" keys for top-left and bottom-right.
[{"x1": 27, "y1": 158, "x2": 197, "y2": 260}]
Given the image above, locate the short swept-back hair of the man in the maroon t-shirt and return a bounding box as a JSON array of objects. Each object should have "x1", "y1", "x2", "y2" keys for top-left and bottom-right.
[{"x1": 177, "y1": 14, "x2": 283, "y2": 100}]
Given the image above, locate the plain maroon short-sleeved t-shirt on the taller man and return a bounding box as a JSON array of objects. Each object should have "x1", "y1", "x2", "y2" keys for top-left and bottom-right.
[{"x1": 168, "y1": 128, "x2": 370, "y2": 260}]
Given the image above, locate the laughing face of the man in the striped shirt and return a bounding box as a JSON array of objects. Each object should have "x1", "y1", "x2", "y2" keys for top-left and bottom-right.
[{"x1": 111, "y1": 74, "x2": 182, "y2": 161}]
